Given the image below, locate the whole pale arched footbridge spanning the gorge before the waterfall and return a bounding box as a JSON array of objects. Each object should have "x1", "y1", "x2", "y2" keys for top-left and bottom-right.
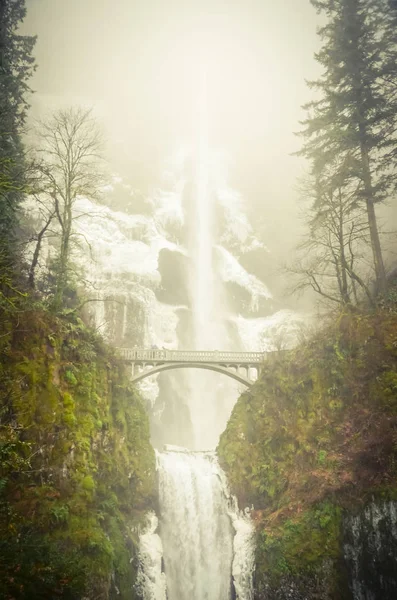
[{"x1": 118, "y1": 348, "x2": 266, "y2": 387}]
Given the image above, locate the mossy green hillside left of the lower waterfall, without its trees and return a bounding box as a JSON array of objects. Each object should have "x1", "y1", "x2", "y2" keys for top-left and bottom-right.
[{"x1": 0, "y1": 310, "x2": 155, "y2": 598}]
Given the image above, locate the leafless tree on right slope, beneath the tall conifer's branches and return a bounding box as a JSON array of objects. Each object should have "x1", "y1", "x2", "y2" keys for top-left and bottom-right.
[{"x1": 287, "y1": 164, "x2": 373, "y2": 305}]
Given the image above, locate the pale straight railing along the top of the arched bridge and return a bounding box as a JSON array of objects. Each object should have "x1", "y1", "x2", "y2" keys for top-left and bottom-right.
[{"x1": 118, "y1": 348, "x2": 268, "y2": 364}]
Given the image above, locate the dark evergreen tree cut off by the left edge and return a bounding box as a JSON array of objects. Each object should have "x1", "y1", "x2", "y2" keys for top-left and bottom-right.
[{"x1": 0, "y1": 0, "x2": 36, "y2": 272}]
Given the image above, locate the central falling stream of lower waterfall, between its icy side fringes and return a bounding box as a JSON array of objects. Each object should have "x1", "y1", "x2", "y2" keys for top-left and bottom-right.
[{"x1": 159, "y1": 452, "x2": 233, "y2": 600}]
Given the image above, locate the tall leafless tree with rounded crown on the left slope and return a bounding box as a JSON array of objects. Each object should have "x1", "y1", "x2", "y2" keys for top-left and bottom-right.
[{"x1": 36, "y1": 108, "x2": 104, "y2": 309}]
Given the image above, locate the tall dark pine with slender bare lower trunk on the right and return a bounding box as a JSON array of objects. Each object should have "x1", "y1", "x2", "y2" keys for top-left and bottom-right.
[{"x1": 300, "y1": 0, "x2": 397, "y2": 291}]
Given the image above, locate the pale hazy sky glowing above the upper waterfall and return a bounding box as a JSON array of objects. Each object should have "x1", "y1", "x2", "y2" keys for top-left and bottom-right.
[{"x1": 24, "y1": 0, "x2": 318, "y2": 254}]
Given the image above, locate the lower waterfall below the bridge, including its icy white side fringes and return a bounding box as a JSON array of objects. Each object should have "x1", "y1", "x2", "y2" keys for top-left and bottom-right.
[{"x1": 138, "y1": 448, "x2": 254, "y2": 600}]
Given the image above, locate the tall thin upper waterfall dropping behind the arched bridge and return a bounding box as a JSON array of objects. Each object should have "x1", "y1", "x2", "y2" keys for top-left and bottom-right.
[{"x1": 186, "y1": 74, "x2": 239, "y2": 450}]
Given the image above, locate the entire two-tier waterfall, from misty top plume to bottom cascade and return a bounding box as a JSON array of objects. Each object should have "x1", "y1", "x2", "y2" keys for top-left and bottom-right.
[{"x1": 137, "y1": 69, "x2": 254, "y2": 600}]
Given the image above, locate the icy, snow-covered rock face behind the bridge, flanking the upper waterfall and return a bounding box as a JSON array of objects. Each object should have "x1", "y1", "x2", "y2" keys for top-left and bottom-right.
[{"x1": 26, "y1": 172, "x2": 288, "y2": 447}]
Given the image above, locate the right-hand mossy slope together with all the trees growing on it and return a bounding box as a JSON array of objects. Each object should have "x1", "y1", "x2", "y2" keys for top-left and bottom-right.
[{"x1": 218, "y1": 0, "x2": 397, "y2": 600}]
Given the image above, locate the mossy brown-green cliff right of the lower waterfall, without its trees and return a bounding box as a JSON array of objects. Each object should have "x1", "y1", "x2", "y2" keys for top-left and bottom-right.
[{"x1": 218, "y1": 306, "x2": 397, "y2": 600}]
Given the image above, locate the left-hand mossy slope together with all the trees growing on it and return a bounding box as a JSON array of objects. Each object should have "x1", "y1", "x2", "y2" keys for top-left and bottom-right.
[{"x1": 0, "y1": 0, "x2": 159, "y2": 600}]
